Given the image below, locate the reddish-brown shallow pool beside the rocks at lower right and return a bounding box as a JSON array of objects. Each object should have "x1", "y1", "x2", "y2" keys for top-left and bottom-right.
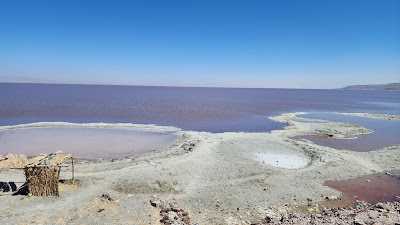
[{"x1": 325, "y1": 171, "x2": 400, "y2": 207}]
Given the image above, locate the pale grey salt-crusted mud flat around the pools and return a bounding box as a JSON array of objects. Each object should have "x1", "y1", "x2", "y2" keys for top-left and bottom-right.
[{"x1": 0, "y1": 113, "x2": 400, "y2": 224}]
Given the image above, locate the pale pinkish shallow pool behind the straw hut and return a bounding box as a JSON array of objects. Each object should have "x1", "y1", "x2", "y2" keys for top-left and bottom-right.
[{"x1": 0, "y1": 128, "x2": 179, "y2": 159}]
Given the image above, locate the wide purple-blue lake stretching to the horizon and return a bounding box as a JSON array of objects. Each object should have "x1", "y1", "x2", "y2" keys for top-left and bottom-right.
[{"x1": 0, "y1": 83, "x2": 400, "y2": 132}]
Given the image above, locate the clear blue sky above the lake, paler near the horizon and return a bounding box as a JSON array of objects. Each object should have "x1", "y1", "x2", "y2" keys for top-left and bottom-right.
[{"x1": 0, "y1": 0, "x2": 400, "y2": 88}]
